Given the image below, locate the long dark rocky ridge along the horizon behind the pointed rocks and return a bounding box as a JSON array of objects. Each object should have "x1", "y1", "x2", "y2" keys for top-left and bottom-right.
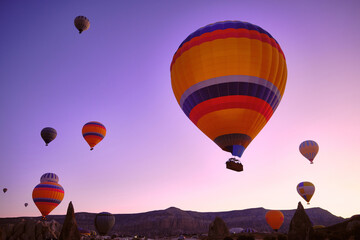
[{"x1": 0, "y1": 207, "x2": 345, "y2": 237}]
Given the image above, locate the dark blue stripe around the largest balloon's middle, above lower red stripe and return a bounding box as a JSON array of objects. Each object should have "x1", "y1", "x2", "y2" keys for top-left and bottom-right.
[{"x1": 182, "y1": 82, "x2": 281, "y2": 117}]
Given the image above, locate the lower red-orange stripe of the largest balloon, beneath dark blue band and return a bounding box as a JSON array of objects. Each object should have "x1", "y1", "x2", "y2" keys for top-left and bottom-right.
[{"x1": 189, "y1": 95, "x2": 274, "y2": 125}]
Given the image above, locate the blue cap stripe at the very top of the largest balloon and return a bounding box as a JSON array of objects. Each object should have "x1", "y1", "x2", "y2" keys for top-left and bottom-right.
[{"x1": 179, "y1": 21, "x2": 277, "y2": 48}]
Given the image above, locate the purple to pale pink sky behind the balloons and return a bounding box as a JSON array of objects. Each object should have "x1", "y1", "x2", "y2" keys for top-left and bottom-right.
[{"x1": 0, "y1": 0, "x2": 360, "y2": 220}]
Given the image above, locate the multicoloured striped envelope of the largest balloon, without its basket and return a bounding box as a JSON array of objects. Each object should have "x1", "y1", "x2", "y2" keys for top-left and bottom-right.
[{"x1": 170, "y1": 21, "x2": 287, "y2": 171}]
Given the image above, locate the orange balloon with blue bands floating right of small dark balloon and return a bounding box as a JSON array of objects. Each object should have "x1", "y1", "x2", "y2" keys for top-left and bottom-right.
[{"x1": 82, "y1": 121, "x2": 106, "y2": 150}]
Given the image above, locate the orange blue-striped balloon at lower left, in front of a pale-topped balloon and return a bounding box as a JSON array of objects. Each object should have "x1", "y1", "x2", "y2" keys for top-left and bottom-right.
[{"x1": 32, "y1": 174, "x2": 64, "y2": 219}]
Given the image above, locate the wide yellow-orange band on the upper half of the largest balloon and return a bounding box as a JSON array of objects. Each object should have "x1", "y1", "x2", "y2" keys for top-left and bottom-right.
[{"x1": 171, "y1": 38, "x2": 287, "y2": 102}]
